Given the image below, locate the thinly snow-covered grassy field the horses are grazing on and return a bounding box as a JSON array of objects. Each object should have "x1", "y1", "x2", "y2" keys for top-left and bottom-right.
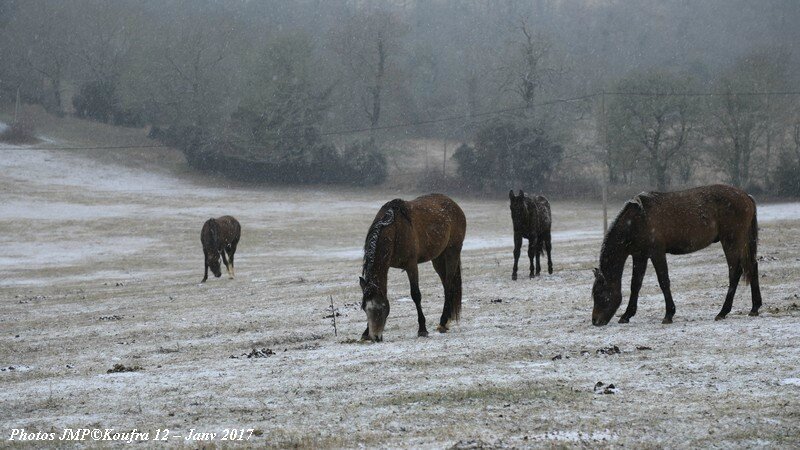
[{"x1": 0, "y1": 140, "x2": 800, "y2": 448}]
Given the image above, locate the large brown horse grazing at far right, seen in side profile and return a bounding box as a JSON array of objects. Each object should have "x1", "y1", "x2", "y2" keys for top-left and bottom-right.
[{"x1": 592, "y1": 185, "x2": 761, "y2": 326}]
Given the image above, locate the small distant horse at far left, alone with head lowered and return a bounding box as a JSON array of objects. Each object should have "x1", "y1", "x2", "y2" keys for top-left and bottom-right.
[{"x1": 200, "y1": 216, "x2": 242, "y2": 283}]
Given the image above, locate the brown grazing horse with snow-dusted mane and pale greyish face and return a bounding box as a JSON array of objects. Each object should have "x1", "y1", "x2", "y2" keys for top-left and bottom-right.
[{"x1": 359, "y1": 194, "x2": 467, "y2": 342}]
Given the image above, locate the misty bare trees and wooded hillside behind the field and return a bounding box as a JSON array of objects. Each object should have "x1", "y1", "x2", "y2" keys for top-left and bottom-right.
[{"x1": 0, "y1": 0, "x2": 800, "y2": 194}]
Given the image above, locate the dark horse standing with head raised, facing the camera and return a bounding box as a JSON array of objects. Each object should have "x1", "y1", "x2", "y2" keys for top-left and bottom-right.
[{"x1": 508, "y1": 191, "x2": 553, "y2": 280}]
